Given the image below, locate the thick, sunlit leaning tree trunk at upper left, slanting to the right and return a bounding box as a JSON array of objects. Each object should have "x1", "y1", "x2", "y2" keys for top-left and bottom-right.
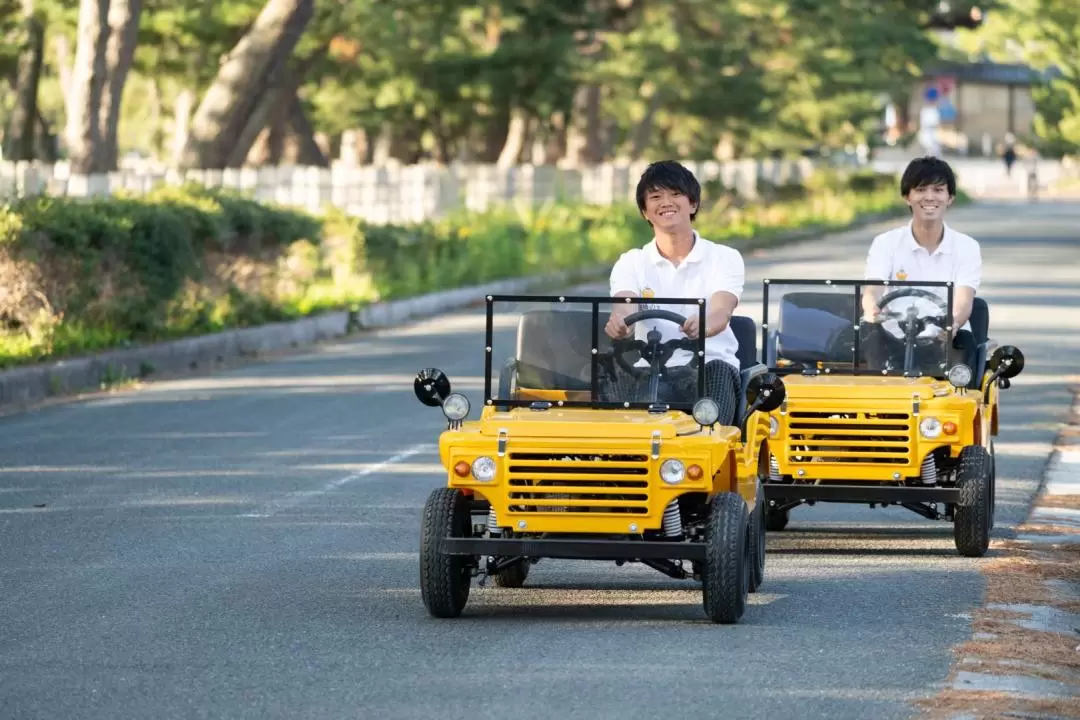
[{"x1": 181, "y1": 0, "x2": 314, "y2": 168}]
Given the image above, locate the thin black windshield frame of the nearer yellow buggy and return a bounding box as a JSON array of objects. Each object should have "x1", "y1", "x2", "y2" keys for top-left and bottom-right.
[{"x1": 484, "y1": 294, "x2": 708, "y2": 412}]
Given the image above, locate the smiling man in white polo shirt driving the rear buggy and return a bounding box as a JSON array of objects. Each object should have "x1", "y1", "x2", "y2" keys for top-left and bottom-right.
[{"x1": 862, "y1": 155, "x2": 983, "y2": 367}]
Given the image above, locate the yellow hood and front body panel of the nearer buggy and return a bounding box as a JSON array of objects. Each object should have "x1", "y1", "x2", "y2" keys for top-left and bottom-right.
[{"x1": 429, "y1": 406, "x2": 769, "y2": 534}]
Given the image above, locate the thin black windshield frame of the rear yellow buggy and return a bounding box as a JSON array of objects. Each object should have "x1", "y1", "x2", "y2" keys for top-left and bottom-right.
[{"x1": 760, "y1": 277, "x2": 956, "y2": 380}]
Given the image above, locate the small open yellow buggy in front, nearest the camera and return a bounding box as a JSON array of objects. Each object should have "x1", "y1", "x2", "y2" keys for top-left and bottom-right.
[{"x1": 415, "y1": 296, "x2": 784, "y2": 623}]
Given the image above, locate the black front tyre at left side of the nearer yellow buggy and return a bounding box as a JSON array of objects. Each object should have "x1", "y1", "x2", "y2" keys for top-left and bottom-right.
[{"x1": 420, "y1": 488, "x2": 472, "y2": 617}]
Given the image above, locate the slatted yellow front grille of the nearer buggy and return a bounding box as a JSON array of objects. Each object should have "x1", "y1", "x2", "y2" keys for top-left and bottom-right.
[{"x1": 509, "y1": 452, "x2": 649, "y2": 515}]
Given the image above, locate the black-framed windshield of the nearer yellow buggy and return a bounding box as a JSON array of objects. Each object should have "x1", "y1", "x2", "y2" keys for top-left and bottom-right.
[{"x1": 485, "y1": 296, "x2": 704, "y2": 411}]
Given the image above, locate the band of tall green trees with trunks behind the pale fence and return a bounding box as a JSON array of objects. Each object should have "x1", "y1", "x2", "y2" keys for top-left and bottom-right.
[{"x1": 0, "y1": 0, "x2": 1080, "y2": 172}]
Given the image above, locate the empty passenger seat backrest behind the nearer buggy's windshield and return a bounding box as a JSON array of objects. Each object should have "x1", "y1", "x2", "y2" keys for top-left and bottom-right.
[{"x1": 517, "y1": 309, "x2": 611, "y2": 390}]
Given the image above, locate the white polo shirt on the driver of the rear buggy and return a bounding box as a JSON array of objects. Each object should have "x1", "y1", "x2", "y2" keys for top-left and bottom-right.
[{"x1": 864, "y1": 222, "x2": 983, "y2": 330}]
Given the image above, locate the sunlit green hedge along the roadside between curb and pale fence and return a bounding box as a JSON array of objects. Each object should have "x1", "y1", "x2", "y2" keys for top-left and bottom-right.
[{"x1": 0, "y1": 167, "x2": 901, "y2": 366}]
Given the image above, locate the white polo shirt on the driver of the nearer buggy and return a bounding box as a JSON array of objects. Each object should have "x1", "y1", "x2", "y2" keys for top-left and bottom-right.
[{"x1": 610, "y1": 231, "x2": 746, "y2": 370}]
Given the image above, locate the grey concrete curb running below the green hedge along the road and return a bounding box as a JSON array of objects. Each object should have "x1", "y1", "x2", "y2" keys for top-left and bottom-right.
[{"x1": 0, "y1": 205, "x2": 901, "y2": 411}]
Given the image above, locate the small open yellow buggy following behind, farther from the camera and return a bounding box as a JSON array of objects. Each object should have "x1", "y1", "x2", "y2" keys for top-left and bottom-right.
[{"x1": 761, "y1": 280, "x2": 1024, "y2": 557}]
